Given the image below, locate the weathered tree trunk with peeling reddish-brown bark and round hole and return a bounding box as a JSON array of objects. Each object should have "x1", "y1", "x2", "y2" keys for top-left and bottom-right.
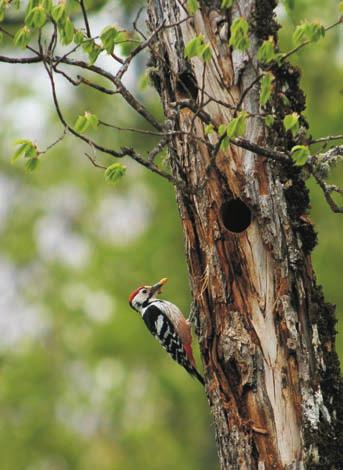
[{"x1": 148, "y1": 0, "x2": 343, "y2": 469}]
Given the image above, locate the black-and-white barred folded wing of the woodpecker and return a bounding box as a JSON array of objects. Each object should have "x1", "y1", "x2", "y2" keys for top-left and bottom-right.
[{"x1": 143, "y1": 304, "x2": 204, "y2": 384}]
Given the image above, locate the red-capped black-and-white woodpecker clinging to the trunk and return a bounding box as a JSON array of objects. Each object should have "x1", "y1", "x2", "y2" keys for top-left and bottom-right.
[{"x1": 129, "y1": 278, "x2": 204, "y2": 385}]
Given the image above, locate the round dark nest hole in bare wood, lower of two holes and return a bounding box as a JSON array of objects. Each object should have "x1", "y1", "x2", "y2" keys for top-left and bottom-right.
[{"x1": 221, "y1": 199, "x2": 251, "y2": 233}]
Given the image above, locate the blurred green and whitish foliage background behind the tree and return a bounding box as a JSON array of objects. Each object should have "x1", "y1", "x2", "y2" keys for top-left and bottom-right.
[{"x1": 0, "y1": 0, "x2": 343, "y2": 470}]
